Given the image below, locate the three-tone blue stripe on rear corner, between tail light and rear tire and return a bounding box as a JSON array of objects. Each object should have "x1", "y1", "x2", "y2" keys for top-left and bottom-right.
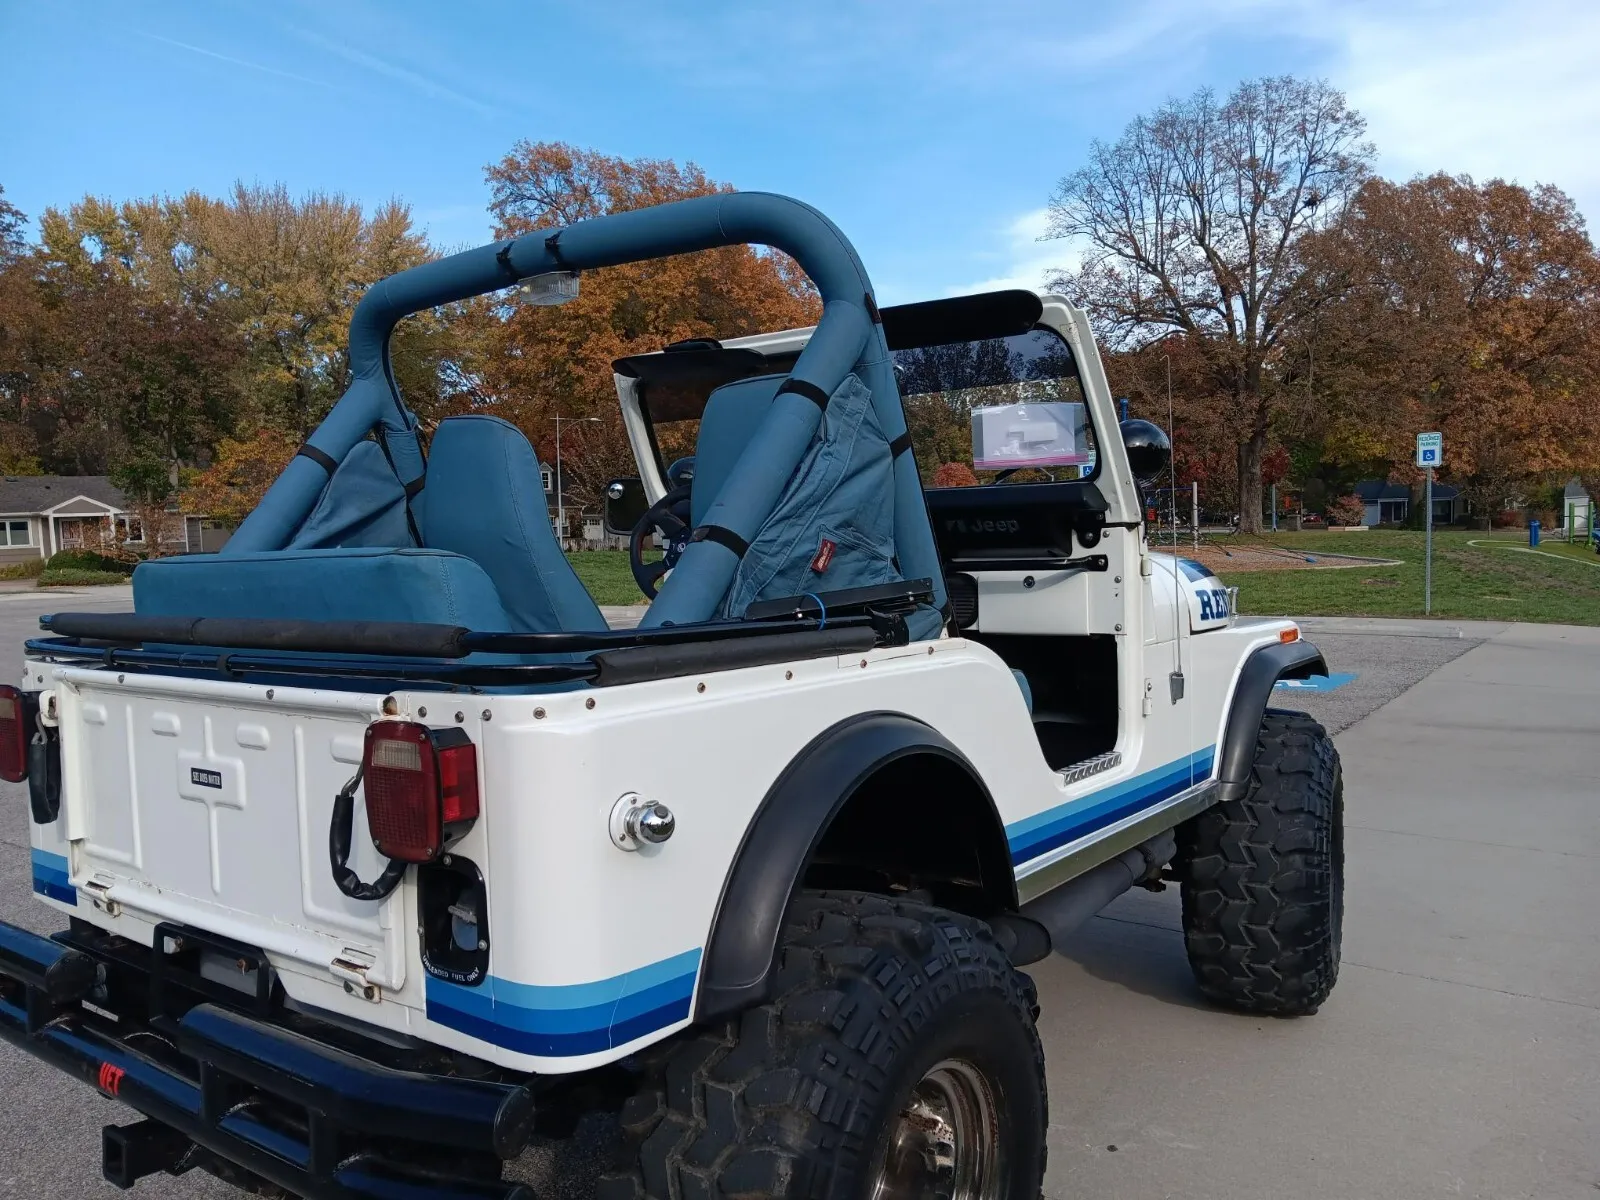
[{"x1": 426, "y1": 949, "x2": 701, "y2": 1056}]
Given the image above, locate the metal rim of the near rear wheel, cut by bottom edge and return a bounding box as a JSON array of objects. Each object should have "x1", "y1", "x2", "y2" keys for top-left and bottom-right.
[{"x1": 870, "y1": 1059, "x2": 1000, "y2": 1200}]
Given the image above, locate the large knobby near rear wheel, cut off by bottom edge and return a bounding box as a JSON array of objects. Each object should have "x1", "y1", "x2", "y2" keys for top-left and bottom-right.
[{"x1": 597, "y1": 891, "x2": 1048, "y2": 1200}]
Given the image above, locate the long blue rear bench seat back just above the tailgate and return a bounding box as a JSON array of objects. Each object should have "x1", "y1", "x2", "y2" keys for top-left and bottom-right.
[{"x1": 133, "y1": 546, "x2": 510, "y2": 630}]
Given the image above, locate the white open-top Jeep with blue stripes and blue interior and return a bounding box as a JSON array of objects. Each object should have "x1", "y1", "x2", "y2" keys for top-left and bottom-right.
[{"x1": 0, "y1": 194, "x2": 1342, "y2": 1200}]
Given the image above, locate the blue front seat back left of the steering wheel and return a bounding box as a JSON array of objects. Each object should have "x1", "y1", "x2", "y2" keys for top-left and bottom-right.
[{"x1": 413, "y1": 416, "x2": 606, "y2": 634}]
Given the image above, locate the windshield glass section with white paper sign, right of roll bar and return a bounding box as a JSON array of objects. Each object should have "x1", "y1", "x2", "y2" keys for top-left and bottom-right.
[{"x1": 893, "y1": 328, "x2": 1096, "y2": 488}]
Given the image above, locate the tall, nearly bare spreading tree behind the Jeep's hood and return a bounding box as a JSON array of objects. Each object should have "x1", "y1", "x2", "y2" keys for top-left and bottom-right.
[{"x1": 1050, "y1": 77, "x2": 1373, "y2": 531}]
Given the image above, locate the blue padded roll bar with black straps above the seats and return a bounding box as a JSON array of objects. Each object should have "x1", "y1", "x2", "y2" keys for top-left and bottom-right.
[{"x1": 224, "y1": 192, "x2": 944, "y2": 626}]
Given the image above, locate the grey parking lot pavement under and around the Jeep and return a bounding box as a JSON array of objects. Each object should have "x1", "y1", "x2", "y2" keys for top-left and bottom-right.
[{"x1": 0, "y1": 589, "x2": 1600, "y2": 1200}]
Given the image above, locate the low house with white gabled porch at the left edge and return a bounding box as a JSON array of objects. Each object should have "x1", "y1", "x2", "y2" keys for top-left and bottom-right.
[{"x1": 0, "y1": 475, "x2": 227, "y2": 563}]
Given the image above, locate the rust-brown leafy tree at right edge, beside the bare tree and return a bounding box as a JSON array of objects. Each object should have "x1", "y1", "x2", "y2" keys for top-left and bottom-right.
[{"x1": 1307, "y1": 174, "x2": 1600, "y2": 512}]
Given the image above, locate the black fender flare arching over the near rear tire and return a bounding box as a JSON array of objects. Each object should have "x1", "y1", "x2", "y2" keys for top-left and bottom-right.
[{"x1": 694, "y1": 712, "x2": 1016, "y2": 1021}]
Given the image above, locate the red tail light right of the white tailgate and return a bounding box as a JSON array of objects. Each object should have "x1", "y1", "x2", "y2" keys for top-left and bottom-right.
[{"x1": 362, "y1": 722, "x2": 478, "y2": 862}]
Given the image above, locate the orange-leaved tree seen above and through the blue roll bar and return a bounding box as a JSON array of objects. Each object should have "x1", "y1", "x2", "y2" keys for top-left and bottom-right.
[{"x1": 456, "y1": 141, "x2": 821, "y2": 524}]
